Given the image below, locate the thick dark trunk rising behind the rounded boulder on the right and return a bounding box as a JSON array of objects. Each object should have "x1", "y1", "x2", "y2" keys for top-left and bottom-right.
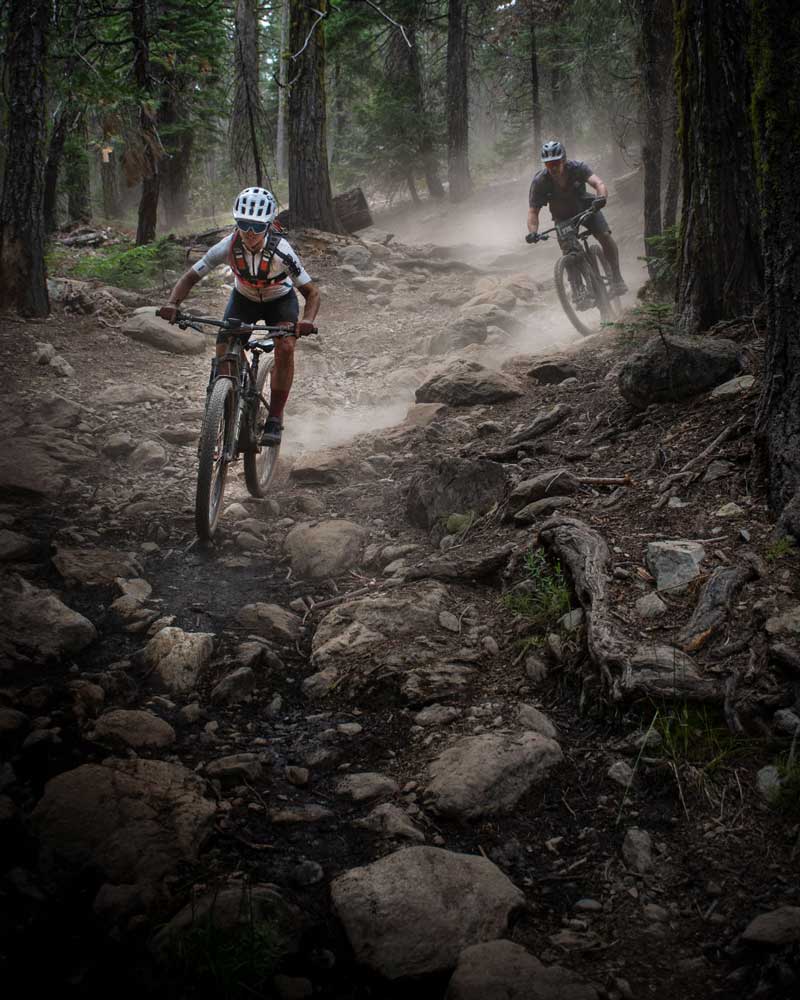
[{"x1": 675, "y1": 0, "x2": 763, "y2": 333}]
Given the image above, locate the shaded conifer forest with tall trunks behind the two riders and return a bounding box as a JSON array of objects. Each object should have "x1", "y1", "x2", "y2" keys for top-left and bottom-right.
[{"x1": 0, "y1": 0, "x2": 800, "y2": 524}]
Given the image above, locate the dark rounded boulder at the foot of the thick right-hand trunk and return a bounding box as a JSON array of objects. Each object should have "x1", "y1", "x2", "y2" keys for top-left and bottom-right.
[{"x1": 619, "y1": 334, "x2": 742, "y2": 410}]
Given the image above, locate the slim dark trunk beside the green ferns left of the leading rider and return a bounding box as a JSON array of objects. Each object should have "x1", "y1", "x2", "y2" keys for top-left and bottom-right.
[{"x1": 131, "y1": 0, "x2": 161, "y2": 246}]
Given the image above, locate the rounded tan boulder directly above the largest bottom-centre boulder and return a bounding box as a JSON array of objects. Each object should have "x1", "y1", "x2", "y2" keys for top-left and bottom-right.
[{"x1": 425, "y1": 732, "x2": 562, "y2": 819}]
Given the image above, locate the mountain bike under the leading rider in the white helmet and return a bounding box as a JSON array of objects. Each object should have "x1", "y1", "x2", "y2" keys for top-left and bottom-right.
[{"x1": 175, "y1": 313, "x2": 316, "y2": 542}]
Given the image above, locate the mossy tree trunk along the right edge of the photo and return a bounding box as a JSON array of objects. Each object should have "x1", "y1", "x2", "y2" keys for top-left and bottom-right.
[{"x1": 751, "y1": 7, "x2": 800, "y2": 530}]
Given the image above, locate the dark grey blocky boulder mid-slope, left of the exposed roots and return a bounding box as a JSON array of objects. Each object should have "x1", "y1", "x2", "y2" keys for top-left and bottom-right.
[{"x1": 406, "y1": 457, "x2": 506, "y2": 531}]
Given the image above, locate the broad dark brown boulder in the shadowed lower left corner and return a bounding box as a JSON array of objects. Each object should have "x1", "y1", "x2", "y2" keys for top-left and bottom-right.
[{"x1": 31, "y1": 759, "x2": 216, "y2": 884}]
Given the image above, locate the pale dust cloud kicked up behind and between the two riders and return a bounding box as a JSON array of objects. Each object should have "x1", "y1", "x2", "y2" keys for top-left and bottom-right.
[{"x1": 284, "y1": 159, "x2": 646, "y2": 455}]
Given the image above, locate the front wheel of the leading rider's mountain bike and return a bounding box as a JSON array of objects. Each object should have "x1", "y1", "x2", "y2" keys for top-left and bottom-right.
[{"x1": 194, "y1": 378, "x2": 236, "y2": 542}]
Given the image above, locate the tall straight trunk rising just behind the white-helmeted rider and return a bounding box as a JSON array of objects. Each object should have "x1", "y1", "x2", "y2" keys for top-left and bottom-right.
[{"x1": 289, "y1": 0, "x2": 342, "y2": 233}]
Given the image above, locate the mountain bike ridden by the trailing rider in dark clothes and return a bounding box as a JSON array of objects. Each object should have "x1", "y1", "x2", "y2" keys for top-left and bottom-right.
[{"x1": 526, "y1": 208, "x2": 622, "y2": 337}]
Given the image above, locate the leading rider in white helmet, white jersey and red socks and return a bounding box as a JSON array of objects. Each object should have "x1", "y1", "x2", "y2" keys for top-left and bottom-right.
[{"x1": 158, "y1": 187, "x2": 320, "y2": 446}]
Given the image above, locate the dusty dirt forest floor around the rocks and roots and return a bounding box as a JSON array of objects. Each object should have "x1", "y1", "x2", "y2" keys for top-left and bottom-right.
[{"x1": 0, "y1": 185, "x2": 800, "y2": 1000}]
